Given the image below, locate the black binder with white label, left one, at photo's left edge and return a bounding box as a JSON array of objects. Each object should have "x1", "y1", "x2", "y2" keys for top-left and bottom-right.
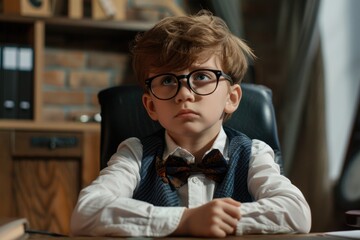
[{"x1": 0, "y1": 45, "x2": 18, "y2": 119}]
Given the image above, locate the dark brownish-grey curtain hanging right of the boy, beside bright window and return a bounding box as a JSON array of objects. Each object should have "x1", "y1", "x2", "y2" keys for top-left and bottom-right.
[{"x1": 278, "y1": 0, "x2": 334, "y2": 232}]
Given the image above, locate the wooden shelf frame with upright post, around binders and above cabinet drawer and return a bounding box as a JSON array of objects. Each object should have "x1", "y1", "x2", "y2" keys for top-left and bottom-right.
[{"x1": 0, "y1": 14, "x2": 151, "y2": 132}]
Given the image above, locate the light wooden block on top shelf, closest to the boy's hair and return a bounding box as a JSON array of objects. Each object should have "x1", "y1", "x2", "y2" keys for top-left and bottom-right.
[{"x1": 91, "y1": 0, "x2": 127, "y2": 20}]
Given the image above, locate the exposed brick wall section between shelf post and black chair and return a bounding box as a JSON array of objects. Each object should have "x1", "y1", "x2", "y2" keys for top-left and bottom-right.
[{"x1": 43, "y1": 48, "x2": 129, "y2": 122}]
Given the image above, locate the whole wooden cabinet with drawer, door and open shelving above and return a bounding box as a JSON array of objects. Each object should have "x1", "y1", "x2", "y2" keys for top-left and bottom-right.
[{"x1": 0, "y1": 15, "x2": 152, "y2": 234}]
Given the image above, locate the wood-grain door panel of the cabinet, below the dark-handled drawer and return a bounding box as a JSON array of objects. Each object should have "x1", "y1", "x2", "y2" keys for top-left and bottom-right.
[{"x1": 13, "y1": 158, "x2": 80, "y2": 234}]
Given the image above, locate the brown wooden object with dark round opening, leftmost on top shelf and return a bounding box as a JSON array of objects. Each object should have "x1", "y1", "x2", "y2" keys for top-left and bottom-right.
[{"x1": 3, "y1": 0, "x2": 51, "y2": 17}]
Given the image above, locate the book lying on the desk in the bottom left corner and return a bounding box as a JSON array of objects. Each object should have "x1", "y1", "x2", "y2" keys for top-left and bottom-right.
[{"x1": 0, "y1": 218, "x2": 29, "y2": 240}]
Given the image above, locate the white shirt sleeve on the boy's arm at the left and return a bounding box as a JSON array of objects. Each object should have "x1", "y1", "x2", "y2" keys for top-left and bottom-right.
[{"x1": 71, "y1": 138, "x2": 185, "y2": 237}]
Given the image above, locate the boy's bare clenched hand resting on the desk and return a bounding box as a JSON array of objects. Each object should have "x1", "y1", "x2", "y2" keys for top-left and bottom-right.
[{"x1": 173, "y1": 198, "x2": 241, "y2": 237}]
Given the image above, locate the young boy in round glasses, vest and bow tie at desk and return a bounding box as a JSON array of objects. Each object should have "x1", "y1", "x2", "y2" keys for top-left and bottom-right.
[{"x1": 71, "y1": 11, "x2": 311, "y2": 237}]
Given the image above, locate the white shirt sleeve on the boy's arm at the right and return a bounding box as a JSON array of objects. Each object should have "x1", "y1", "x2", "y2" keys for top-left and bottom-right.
[{"x1": 236, "y1": 140, "x2": 311, "y2": 235}]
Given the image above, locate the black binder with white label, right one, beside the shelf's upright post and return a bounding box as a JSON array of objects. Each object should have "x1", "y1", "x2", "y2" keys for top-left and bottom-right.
[{"x1": 17, "y1": 47, "x2": 34, "y2": 119}]
